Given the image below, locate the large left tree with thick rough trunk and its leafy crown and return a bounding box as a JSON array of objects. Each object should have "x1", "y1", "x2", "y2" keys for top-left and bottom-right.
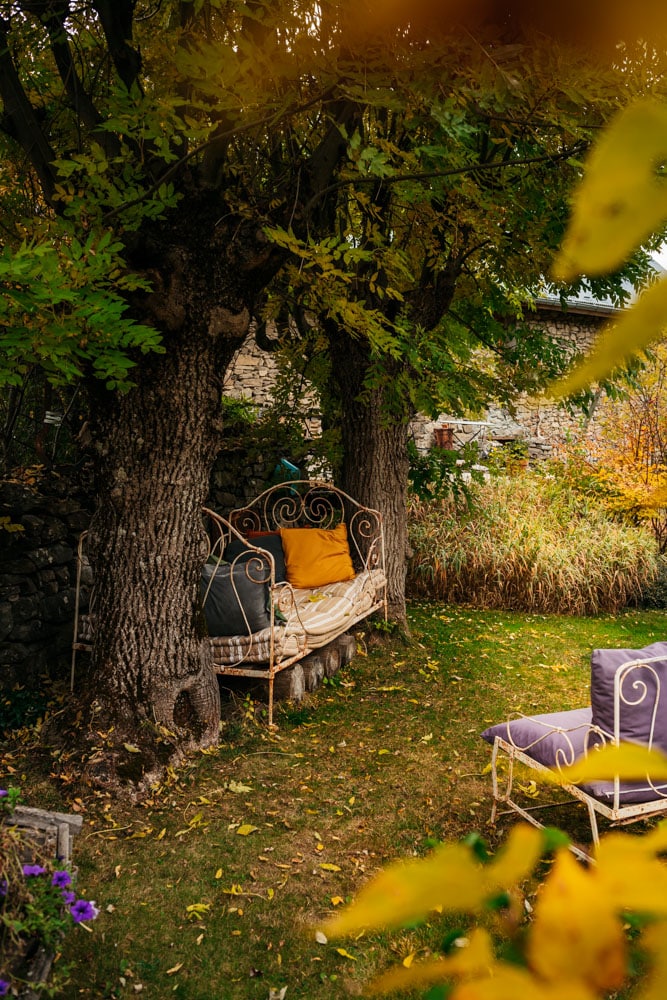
[{"x1": 0, "y1": 0, "x2": 430, "y2": 772}]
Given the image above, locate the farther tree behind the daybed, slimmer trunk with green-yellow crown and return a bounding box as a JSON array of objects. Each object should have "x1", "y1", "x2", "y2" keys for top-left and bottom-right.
[{"x1": 260, "y1": 33, "x2": 660, "y2": 622}]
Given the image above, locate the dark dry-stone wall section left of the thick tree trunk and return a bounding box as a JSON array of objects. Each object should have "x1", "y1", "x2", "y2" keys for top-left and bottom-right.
[{"x1": 0, "y1": 481, "x2": 90, "y2": 689}]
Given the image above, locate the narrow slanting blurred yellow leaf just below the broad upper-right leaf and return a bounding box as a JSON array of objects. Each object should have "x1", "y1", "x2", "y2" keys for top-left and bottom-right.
[{"x1": 548, "y1": 278, "x2": 667, "y2": 398}]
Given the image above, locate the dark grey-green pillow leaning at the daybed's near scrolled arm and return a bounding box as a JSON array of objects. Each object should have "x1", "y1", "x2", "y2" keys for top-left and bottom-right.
[{"x1": 200, "y1": 558, "x2": 271, "y2": 635}]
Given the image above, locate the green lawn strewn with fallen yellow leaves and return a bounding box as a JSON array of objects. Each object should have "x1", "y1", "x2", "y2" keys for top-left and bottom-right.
[{"x1": 3, "y1": 603, "x2": 667, "y2": 1000}]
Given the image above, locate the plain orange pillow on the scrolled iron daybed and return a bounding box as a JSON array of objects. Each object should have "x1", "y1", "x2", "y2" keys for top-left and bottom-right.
[{"x1": 280, "y1": 523, "x2": 355, "y2": 588}]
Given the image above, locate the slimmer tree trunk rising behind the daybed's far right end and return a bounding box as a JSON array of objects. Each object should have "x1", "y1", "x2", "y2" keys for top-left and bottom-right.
[{"x1": 330, "y1": 331, "x2": 410, "y2": 628}]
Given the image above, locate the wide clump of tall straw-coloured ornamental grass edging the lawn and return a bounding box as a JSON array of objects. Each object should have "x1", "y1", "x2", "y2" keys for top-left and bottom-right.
[{"x1": 408, "y1": 470, "x2": 658, "y2": 615}]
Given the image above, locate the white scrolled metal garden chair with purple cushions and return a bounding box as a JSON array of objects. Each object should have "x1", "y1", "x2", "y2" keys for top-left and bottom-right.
[{"x1": 482, "y1": 642, "x2": 667, "y2": 860}]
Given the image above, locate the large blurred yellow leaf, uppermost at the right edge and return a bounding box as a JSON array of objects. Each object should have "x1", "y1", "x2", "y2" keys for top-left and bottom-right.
[{"x1": 553, "y1": 100, "x2": 667, "y2": 281}]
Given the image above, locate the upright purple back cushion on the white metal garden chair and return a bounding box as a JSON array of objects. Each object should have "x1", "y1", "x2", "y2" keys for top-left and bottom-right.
[{"x1": 591, "y1": 642, "x2": 667, "y2": 752}]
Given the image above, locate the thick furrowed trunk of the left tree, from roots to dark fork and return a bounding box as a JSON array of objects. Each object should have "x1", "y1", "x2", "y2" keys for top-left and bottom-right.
[{"x1": 78, "y1": 205, "x2": 276, "y2": 784}]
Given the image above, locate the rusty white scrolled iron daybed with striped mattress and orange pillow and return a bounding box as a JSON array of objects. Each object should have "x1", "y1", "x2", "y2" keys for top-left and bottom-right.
[{"x1": 72, "y1": 480, "x2": 387, "y2": 725}]
